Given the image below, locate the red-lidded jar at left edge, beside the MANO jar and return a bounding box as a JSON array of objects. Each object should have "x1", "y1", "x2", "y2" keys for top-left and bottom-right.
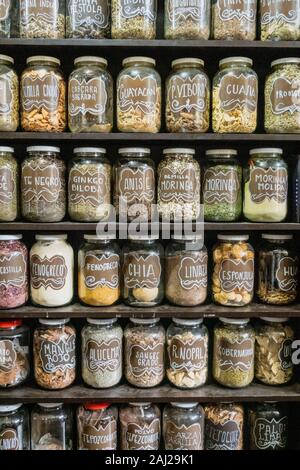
[{"x1": 0, "y1": 320, "x2": 30, "y2": 390}]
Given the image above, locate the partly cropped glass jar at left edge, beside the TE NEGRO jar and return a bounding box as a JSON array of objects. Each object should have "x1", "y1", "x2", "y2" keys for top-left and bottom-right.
[{"x1": 0, "y1": 147, "x2": 19, "y2": 222}]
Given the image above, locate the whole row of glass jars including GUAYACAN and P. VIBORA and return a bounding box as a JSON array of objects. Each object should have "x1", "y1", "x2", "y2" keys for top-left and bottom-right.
[{"x1": 0, "y1": 55, "x2": 300, "y2": 133}]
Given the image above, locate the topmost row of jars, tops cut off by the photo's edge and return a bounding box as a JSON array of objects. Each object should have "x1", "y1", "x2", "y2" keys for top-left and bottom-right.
[{"x1": 0, "y1": 0, "x2": 300, "y2": 41}]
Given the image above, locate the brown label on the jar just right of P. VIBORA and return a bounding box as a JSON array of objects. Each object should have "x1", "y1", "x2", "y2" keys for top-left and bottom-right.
[{"x1": 219, "y1": 73, "x2": 258, "y2": 113}]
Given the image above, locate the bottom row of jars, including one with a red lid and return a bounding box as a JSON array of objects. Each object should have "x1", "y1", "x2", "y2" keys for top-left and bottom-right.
[{"x1": 0, "y1": 402, "x2": 290, "y2": 451}]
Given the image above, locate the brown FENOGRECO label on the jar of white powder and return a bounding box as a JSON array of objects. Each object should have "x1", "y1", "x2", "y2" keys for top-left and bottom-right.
[{"x1": 30, "y1": 255, "x2": 68, "y2": 290}]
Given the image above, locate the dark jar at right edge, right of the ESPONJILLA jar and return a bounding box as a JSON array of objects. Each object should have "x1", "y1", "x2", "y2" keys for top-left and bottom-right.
[{"x1": 257, "y1": 234, "x2": 299, "y2": 305}]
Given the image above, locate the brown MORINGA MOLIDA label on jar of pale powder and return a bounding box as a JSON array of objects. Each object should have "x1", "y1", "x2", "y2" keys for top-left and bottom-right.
[{"x1": 249, "y1": 168, "x2": 288, "y2": 204}]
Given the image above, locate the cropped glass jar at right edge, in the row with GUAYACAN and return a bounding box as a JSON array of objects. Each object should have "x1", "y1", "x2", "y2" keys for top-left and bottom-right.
[{"x1": 265, "y1": 58, "x2": 300, "y2": 134}]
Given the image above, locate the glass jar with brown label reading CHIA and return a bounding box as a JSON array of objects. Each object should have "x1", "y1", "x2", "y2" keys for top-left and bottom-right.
[{"x1": 123, "y1": 234, "x2": 164, "y2": 307}]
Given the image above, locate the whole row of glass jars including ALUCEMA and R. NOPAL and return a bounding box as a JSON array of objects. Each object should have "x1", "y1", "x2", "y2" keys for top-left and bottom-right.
[{"x1": 0, "y1": 317, "x2": 294, "y2": 390}]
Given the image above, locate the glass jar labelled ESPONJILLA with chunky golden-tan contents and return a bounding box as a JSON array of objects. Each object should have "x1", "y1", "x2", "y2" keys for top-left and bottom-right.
[{"x1": 212, "y1": 235, "x2": 254, "y2": 307}]
